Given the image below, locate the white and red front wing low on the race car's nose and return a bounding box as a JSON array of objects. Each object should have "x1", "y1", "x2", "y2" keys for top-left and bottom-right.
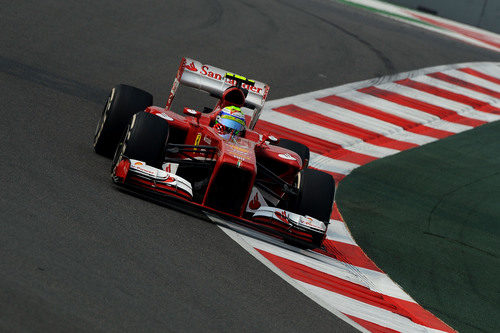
[{"x1": 112, "y1": 157, "x2": 328, "y2": 247}]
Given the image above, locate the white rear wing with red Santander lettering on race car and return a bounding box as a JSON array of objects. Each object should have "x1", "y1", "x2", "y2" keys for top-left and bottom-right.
[{"x1": 166, "y1": 58, "x2": 269, "y2": 129}]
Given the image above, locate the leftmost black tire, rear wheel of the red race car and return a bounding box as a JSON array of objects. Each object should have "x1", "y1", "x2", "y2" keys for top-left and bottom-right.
[{"x1": 94, "y1": 84, "x2": 153, "y2": 157}]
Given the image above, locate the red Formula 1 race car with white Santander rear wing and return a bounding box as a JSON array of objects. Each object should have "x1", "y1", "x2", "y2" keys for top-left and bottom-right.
[{"x1": 94, "y1": 58, "x2": 335, "y2": 248}]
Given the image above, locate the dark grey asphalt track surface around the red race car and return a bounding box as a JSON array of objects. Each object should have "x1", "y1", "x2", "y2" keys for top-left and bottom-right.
[{"x1": 0, "y1": 0, "x2": 499, "y2": 332}]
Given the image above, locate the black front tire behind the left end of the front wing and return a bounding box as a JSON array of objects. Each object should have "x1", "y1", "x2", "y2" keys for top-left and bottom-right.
[{"x1": 113, "y1": 112, "x2": 169, "y2": 168}]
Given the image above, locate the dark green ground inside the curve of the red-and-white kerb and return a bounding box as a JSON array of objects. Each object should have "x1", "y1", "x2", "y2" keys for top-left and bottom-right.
[{"x1": 337, "y1": 121, "x2": 500, "y2": 332}]
